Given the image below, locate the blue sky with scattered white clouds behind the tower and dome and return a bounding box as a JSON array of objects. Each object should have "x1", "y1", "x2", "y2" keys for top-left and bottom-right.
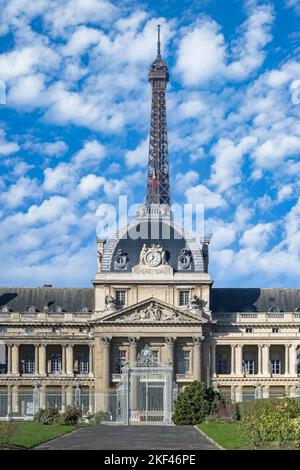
[{"x1": 0, "y1": 0, "x2": 300, "y2": 287}]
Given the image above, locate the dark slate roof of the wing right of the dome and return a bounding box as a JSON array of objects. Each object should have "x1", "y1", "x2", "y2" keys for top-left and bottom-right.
[{"x1": 210, "y1": 288, "x2": 300, "y2": 312}]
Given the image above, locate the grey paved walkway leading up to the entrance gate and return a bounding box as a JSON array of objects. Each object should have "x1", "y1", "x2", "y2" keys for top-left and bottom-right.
[{"x1": 36, "y1": 425, "x2": 218, "y2": 450}]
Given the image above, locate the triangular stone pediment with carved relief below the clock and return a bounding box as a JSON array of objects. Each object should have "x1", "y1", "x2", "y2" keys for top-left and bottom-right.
[{"x1": 101, "y1": 297, "x2": 206, "y2": 324}]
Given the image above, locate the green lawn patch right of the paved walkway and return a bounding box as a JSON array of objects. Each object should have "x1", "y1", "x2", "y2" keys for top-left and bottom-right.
[{"x1": 198, "y1": 422, "x2": 252, "y2": 450}]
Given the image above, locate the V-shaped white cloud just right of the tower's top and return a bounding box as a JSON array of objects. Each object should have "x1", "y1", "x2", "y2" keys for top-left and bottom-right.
[{"x1": 176, "y1": 5, "x2": 274, "y2": 86}]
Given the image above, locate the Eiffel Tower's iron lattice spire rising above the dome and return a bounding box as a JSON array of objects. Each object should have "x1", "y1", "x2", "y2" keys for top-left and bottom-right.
[{"x1": 146, "y1": 25, "x2": 170, "y2": 206}]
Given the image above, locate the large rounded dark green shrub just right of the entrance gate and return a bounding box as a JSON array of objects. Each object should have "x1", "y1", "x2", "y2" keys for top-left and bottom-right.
[{"x1": 172, "y1": 380, "x2": 220, "y2": 424}]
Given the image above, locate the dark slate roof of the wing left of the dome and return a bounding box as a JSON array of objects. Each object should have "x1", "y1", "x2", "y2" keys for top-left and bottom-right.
[{"x1": 0, "y1": 287, "x2": 94, "y2": 312}]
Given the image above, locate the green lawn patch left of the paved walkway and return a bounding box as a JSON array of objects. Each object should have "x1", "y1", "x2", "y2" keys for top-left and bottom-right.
[{"x1": 4, "y1": 421, "x2": 77, "y2": 448}]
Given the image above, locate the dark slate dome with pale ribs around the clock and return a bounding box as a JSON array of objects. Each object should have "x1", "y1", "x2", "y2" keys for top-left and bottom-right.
[{"x1": 101, "y1": 219, "x2": 205, "y2": 272}]
